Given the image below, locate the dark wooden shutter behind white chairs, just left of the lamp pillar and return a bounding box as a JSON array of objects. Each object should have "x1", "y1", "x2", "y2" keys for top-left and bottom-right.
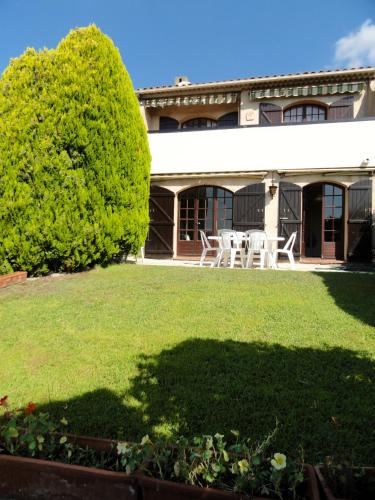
[{"x1": 233, "y1": 182, "x2": 266, "y2": 231}]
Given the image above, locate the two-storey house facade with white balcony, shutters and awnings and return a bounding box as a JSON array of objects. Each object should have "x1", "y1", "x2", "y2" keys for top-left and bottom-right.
[{"x1": 137, "y1": 67, "x2": 375, "y2": 262}]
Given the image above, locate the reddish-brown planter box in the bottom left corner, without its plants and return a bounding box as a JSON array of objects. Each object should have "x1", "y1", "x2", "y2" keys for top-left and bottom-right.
[{"x1": 0, "y1": 436, "x2": 138, "y2": 500}]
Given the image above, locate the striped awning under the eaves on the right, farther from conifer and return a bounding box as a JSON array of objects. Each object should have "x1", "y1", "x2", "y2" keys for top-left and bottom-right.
[{"x1": 249, "y1": 82, "x2": 365, "y2": 101}]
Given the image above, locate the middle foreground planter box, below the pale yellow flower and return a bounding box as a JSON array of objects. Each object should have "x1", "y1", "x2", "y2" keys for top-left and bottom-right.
[{"x1": 138, "y1": 465, "x2": 320, "y2": 500}]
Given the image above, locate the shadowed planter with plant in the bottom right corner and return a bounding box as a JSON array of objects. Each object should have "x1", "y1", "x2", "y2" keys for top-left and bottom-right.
[{"x1": 315, "y1": 458, "x2": 375, "y2": 500}]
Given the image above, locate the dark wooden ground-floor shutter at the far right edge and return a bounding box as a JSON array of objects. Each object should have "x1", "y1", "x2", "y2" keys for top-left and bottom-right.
[{"x1": 348, "y1": 179, "x2": 372, "y2": 262}]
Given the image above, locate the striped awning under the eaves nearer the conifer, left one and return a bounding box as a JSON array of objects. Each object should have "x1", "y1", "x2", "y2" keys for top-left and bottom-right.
[{"x1": 139, "y1": 92, "x2": 238, "y2": 108}]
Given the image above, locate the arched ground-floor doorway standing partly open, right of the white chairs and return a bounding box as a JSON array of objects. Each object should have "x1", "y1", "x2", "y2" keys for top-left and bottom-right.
[{"x1": 302, "y1": 182, "x2": 345, "y2": 260}]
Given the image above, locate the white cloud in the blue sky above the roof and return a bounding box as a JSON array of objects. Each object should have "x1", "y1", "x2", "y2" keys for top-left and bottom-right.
[{"x1": 335, "y1": 19, "x2": 375, "y2": 67}]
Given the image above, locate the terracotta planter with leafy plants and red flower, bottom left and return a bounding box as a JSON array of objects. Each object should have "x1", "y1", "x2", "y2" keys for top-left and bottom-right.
[{"x1": 0, "y1": 396, "x2": 138, "y2": 500}]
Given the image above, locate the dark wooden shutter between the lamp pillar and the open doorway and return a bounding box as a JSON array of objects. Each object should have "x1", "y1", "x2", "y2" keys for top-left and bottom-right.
[{"x1": 279, "y1": 182, "x2": 302, "y2": 255}]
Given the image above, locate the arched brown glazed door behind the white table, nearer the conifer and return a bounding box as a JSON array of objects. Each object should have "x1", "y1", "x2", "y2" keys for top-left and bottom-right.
[{"x1": 177, "y1": 186, "x2": 233, "y2": 255}]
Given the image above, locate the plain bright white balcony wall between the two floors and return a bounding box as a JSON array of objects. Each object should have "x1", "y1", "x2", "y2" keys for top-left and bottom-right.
[{"x1": 149, "y1": 120, "x2": 375, "y2": 174}]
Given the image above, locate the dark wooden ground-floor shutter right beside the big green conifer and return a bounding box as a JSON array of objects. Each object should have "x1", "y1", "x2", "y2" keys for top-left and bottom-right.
[{"x1": 145, "y1": 186, "x2": 174, "y2": 258}]
